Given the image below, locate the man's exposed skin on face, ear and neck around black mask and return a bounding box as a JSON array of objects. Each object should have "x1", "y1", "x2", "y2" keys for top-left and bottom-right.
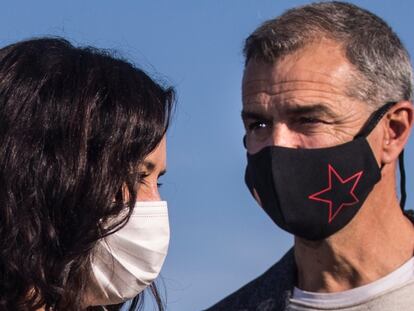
[{"x1": 242, "y1": 39, "x2": 414, "y2": 293}]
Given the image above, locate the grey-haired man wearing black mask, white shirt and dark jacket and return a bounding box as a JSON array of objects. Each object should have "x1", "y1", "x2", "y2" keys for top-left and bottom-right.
[{"x1": 209, "y1": 2, "x2": 414, "y2": 311}]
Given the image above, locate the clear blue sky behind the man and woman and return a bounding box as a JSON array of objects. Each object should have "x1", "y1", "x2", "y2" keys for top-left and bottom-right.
[{"x1": 0, "y1": 0, "x2": 414, "y2": 311}]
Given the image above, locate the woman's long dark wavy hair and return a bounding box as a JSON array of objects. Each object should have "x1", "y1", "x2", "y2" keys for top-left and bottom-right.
[{"x1": 0, "y1": 38, "x2": 174, "y2": 310}]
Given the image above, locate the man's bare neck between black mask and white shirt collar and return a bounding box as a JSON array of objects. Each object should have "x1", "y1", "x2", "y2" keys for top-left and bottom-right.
[{"x1": 295, "y1": 179, "x2": 414, "y2": 292}]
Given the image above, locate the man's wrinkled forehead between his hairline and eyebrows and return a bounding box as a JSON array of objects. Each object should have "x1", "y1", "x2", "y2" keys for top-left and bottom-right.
[{"x1": 242, "y1": 39, "x2": 368, "y2": 114}]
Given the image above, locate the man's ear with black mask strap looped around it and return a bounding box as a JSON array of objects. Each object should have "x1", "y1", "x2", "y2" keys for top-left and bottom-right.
[{"x1": 381, "y1": 101, "x2": 414, "y2": 164}]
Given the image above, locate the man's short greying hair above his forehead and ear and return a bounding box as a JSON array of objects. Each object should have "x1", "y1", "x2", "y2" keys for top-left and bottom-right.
[{"x1": 244, "y1": 1, "x2": 413, "y2": 107}]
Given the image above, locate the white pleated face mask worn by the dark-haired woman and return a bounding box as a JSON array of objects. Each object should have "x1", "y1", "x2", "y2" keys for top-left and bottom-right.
[{"x1": 86, "y1": 201, "x2": 170, "y2": 306}]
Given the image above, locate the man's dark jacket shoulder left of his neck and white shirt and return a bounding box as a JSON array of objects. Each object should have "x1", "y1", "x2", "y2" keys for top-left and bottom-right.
[{"x1": 206, "y1": 249, "x2": 296, "y2": 311}]
